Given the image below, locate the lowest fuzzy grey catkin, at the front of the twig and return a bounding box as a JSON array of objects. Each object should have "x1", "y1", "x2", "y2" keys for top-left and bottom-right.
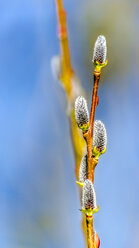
[{"x1": 82, "y1": 179, "x2": 97, "y2": 209}]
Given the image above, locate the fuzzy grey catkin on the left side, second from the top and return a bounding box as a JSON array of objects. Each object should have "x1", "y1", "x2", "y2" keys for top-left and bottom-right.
[{"x1": 75, "y1": 96, "x2": 89, "y2": 126}]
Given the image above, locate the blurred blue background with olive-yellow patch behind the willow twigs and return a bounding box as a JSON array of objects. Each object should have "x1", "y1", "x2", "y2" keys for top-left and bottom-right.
[{"x1": 0, "y1": 0, "x2": 139, "y2": 248}]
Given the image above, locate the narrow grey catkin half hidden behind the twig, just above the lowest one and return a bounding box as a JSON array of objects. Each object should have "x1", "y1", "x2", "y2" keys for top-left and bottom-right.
[{"x1": 79, "y1": 154, "x2": 87, "y2": 183}]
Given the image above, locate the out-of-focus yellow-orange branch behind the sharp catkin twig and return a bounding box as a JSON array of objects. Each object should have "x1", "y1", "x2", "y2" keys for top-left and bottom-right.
[{"x1": 55, "y1": 0, "x2": 86, "y2": 246}]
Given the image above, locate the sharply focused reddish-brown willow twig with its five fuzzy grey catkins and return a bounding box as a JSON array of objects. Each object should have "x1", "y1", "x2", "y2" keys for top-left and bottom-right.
[{"x1": 75, "y1": 35, "x2": 107, "y2": 248}]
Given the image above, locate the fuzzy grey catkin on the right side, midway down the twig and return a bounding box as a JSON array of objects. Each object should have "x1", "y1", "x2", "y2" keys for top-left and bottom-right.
[{"x1": 93, "y1": 120, "x2": 107, "y2": 152}]
